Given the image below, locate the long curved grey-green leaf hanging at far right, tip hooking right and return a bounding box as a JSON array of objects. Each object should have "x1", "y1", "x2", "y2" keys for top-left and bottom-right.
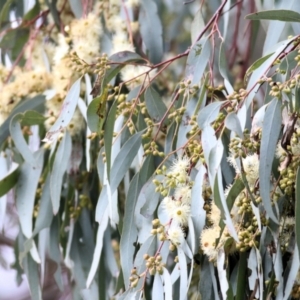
[{"x1": 259, "y1": 98, "x2": 281, "y2": 223}]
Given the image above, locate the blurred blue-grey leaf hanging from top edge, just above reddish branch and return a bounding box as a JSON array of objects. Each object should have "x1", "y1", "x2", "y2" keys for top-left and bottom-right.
[{"x1": 139, "y1": 0, "x2": 163, "y2": 64}]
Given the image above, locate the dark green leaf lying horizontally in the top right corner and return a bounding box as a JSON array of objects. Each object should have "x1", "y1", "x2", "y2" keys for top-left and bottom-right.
[{"x1": 246, "y1": 9, "x2": 300, "y2": 22}]
